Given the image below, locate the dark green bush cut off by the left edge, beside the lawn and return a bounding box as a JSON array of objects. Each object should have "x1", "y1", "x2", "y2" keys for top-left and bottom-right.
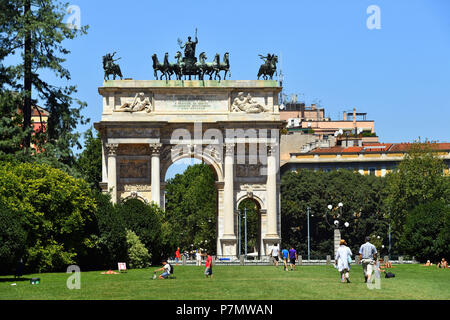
[{"x1": 0, "y1": 203, "x2": 27, "y2": 273}]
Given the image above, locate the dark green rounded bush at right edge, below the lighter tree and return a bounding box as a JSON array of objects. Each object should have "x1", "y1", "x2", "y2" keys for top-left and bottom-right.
[{"x1": 400, "y1": 200, "x2": 450, "y2": 262}]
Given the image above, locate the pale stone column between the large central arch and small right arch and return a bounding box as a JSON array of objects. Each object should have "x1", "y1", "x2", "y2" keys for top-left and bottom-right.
[{"x1": 221, "y1": 143, "x2": 236, "y2": 255}]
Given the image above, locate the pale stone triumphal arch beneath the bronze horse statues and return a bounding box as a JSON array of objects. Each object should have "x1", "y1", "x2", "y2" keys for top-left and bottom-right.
[{"x1": 95, "y1": 80, "x2": 282, "y2": 256}]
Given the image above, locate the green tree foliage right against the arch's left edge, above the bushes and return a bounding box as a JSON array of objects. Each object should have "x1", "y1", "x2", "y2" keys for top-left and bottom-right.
[{"x1": 76, "y1": 128, "x2": 102, "y2": 190}]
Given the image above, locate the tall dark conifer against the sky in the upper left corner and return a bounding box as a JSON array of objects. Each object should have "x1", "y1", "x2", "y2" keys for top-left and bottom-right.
[{"x1": 0, "y1": 0, "x2": 87, "y2": 165}]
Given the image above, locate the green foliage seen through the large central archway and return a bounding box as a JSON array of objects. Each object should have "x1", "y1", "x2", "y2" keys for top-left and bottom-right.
[{"x1": 165, "y1": 164, "x2": 217, "y2": 253}]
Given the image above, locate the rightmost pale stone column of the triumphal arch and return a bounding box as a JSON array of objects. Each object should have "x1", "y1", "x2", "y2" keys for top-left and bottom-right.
[{"x1": 266, "y1": 145, "x2": 279, "y2": 239}]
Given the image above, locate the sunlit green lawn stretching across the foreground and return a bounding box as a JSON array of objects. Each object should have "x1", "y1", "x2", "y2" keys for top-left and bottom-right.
[{"x1": 0, "y1": 265, "x2": 450, "y2": 300}]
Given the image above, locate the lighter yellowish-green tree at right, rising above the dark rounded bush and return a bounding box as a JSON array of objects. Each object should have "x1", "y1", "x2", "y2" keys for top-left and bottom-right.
[{"x1": 386, "y1": 143, "x2": 450, "y2": 248}]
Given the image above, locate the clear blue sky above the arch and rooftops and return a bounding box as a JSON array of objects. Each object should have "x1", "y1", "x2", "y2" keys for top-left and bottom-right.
[{"x1": 39, "y1": 0, "x2": 450, "y2": 155}]
